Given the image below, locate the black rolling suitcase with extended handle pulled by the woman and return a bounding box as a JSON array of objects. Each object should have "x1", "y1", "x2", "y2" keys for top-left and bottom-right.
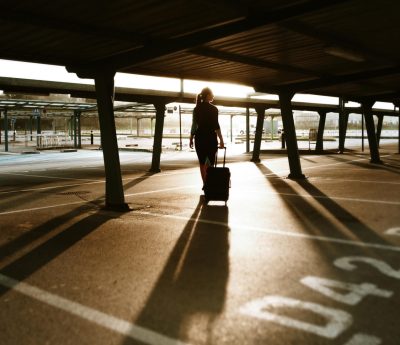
[{"x1": 204, "y1": 147, "x2": 231, "y2": 204}]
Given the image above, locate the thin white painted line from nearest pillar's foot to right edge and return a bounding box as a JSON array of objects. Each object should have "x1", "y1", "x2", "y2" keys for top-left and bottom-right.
[{"x1": 135, "y1": 211, "x2": 400, "y2": 252}]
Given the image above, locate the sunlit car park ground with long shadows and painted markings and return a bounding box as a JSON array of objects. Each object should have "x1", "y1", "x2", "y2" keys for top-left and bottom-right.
[{"x1": 0, "y1": 145, "x2": 400, "y2": 345}]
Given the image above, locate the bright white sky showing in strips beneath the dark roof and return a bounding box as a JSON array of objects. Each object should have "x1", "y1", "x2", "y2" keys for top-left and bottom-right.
[{"x1": 0, "y1": 59, "x2": 393, "y2": 110}]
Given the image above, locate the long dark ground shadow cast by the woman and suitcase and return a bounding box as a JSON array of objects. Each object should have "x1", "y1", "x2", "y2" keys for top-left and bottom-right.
[{"x1": 131, "y1": 197, "x2": 229, "y2": 344}]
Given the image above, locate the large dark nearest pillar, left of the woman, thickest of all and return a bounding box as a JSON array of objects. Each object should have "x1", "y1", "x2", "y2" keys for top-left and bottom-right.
[{"x1": 95, "y1": 71, "x2": 129, "y2": 211}]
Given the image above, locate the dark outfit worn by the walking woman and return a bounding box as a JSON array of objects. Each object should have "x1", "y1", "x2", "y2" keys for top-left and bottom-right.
[{"x1": 191, "y1": 102, "x2": 220, "y2": 165}]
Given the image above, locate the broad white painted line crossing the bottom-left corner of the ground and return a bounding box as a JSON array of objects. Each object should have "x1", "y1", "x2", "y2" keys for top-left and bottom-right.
[{"x1": 0, "y1": 274, "x2": 190, "y2": 345}]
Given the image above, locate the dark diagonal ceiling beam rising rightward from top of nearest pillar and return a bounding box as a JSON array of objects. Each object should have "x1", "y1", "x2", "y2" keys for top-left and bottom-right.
[{"x1": 67, "y1": 0, "x2": 349, "y2": 77}]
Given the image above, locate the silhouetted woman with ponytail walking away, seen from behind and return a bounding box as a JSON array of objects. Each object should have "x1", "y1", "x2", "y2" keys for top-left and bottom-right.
[{"x1": 189, "y1": 87, "x2": 224, "y2": 187}]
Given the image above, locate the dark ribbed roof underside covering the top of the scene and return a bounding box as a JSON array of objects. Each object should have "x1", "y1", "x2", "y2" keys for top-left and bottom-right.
[{"x1": 0, "y1": 0, "x2": 400, "y2": 102}]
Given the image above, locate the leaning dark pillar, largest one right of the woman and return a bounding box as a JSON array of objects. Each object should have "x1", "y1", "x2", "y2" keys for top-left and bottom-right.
[{"x1": 279, "y1": 92, "x2": 305, "y2": 178}]
